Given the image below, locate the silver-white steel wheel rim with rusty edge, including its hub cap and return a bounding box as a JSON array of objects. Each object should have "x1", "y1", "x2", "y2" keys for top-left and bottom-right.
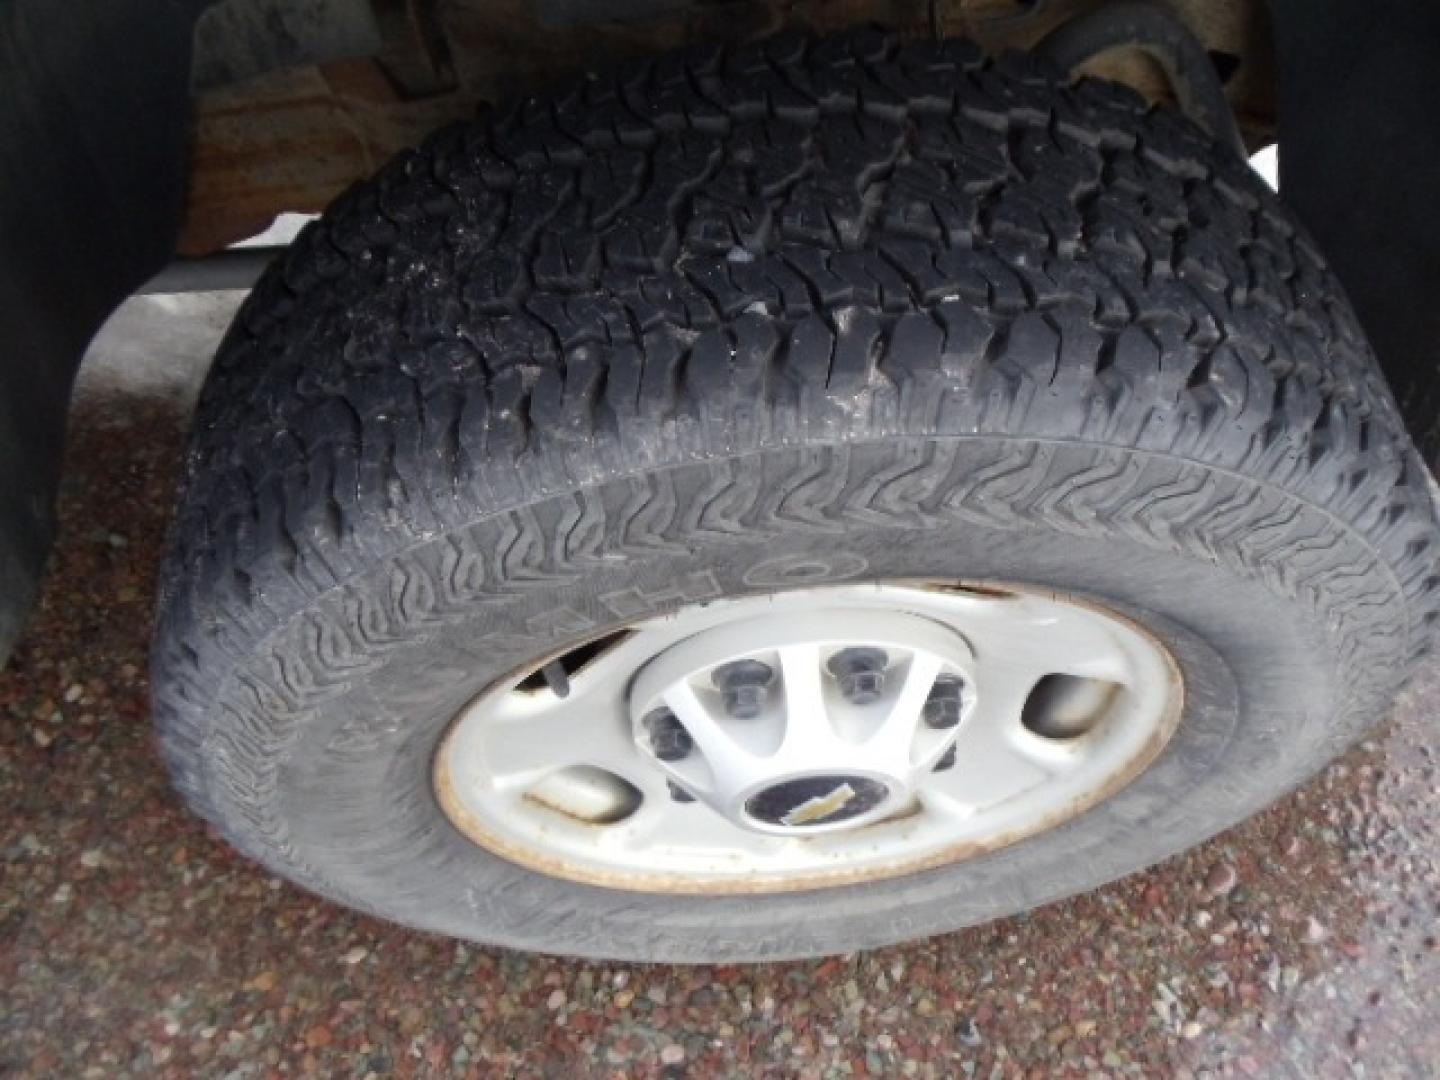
[{"x1": 433, "y1": 583, "x2": 1184, "y2": 894}]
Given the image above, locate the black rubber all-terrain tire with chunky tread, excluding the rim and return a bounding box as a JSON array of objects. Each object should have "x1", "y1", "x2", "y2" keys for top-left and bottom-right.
[{"x1": 154, "y1": 33, "x2": 1440, "y2": 962}]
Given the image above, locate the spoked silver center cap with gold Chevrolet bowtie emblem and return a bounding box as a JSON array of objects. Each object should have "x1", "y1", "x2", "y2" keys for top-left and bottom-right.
[{"x1": 629, "y1": 608, "x2": 971, "y2": 838}]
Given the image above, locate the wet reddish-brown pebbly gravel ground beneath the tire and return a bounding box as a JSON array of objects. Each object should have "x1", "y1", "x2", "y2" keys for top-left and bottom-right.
[{"x1": 0, "y1": 292, "x2": 1440, "y2": 1077}]
